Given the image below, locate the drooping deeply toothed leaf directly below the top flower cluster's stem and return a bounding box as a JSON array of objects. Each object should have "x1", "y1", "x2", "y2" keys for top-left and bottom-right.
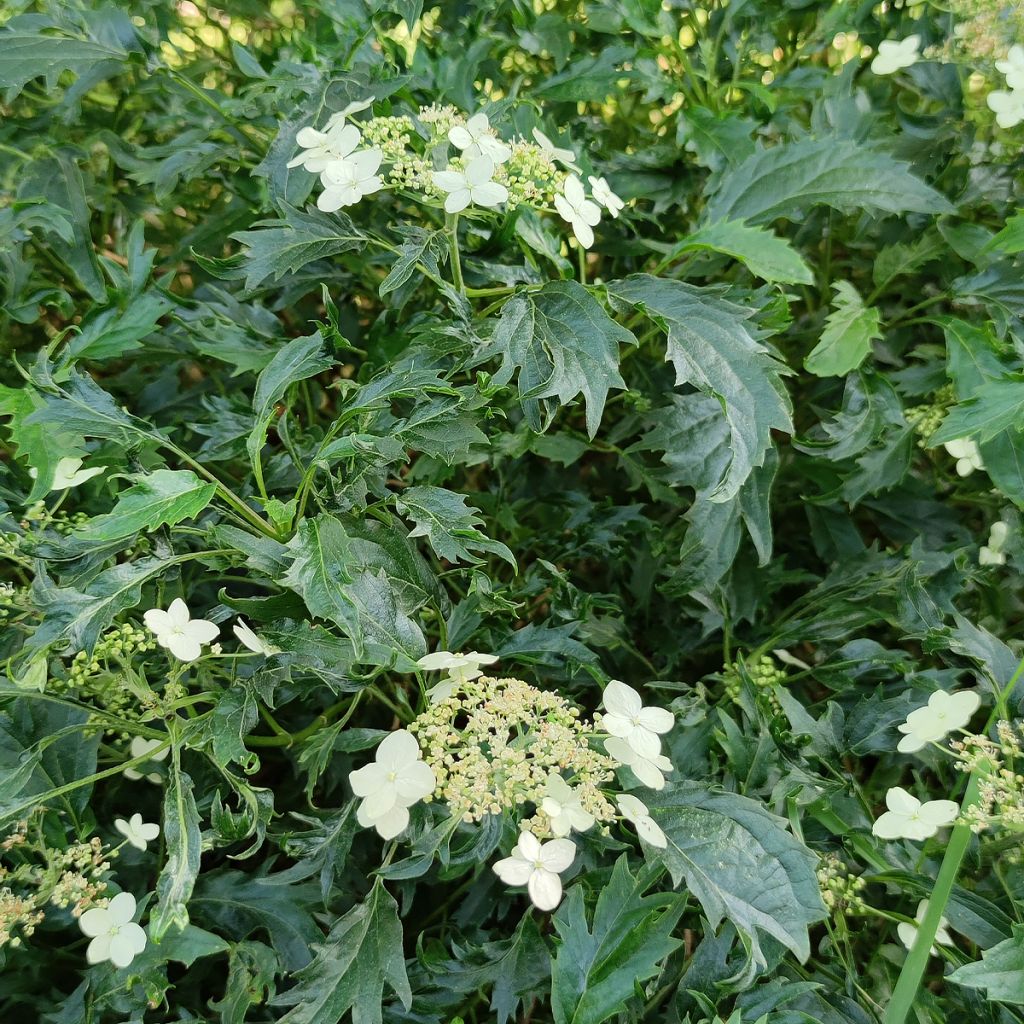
[{"x1": 474, "y1": 281, "x2": 636, "y2": 437}]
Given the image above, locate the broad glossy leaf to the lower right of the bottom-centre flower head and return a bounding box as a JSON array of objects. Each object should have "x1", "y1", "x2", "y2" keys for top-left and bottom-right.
[{"x1": 644, "y1": 783, "x2": 827, "y2": 965}]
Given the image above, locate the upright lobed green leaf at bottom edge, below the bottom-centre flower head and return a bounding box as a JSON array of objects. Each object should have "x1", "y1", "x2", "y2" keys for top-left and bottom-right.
[{"x1": 551, "y1": 855, "x2": 686, "y2": 1024}]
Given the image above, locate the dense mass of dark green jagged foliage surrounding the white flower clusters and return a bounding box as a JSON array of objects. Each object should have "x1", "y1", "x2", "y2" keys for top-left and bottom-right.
[{"x1": 0, "y1": 0, "x2": 1024, "y2": 1024}]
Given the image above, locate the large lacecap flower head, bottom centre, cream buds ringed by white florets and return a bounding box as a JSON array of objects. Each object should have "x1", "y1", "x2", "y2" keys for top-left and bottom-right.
[{"x1": 348, "y1": 651, "x2": 674, "y2": 910}]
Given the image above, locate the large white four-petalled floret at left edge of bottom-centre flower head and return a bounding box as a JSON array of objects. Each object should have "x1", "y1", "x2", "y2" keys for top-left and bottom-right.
[{"x1": 348, "y1": 729, "x2": 437, "y2": 839}]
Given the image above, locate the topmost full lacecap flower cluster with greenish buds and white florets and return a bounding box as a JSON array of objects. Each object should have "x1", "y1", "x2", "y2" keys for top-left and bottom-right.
[{"x1": 288, "y1": 97, "x2": 625, "y2": 249}]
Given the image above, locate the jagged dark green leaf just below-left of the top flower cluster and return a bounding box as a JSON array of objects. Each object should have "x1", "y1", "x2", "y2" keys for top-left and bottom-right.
[{"x1": 231, "y1": 206, "x2": 366, "y2": 292}]
